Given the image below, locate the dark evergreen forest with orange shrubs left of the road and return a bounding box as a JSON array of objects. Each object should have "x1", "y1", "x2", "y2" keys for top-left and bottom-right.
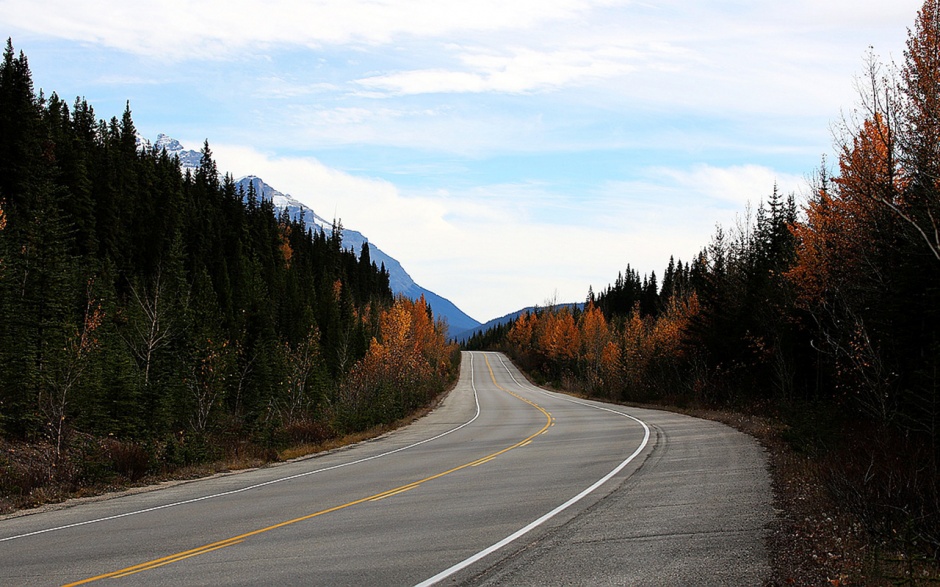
[{"x1": 0, "y1": 40, "x2": 459, "y2": 511}]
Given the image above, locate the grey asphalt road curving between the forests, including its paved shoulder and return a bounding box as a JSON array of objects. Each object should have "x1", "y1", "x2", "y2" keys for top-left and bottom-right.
[{"x1": 0, "y1": 353, "x2": 772, "y2": 586}]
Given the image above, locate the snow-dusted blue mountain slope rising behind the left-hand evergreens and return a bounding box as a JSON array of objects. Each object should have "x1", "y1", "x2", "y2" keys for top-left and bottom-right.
[{"x1": 150, "y1": 134, "x2": 480, "y2": 337}]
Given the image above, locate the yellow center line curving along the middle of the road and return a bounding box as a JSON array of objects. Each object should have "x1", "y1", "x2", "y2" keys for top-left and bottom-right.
[{"x1": 63, "y1": 355, "x2": 554, "y2": 587}]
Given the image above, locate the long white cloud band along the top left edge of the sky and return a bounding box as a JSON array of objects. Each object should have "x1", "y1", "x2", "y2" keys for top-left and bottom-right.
[{"x1": 0, "y1": 0, "x2": 606, "y2": 60}]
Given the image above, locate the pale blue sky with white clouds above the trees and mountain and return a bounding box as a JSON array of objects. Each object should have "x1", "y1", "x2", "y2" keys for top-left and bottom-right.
[{"x1": 0, "y1": 0, "x2": 921, "y2": 322}]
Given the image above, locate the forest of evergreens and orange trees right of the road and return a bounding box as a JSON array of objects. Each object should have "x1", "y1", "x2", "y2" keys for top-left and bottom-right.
[{"x1": 468, "y1": 0, "x2": 940, "y2": 576}]
